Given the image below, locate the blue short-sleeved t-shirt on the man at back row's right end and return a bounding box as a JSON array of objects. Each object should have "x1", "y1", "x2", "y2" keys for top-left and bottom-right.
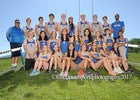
[{"x1": 111, "y1": 21, "x2": 124, "y2": 38}]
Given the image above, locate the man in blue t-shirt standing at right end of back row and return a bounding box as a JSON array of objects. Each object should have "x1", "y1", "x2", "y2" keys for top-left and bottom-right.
[{"x1": 111, "y1": 13, "x2": 125, "y2": 41}]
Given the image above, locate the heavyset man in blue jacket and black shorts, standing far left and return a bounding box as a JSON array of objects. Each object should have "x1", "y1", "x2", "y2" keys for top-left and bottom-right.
[{"x1": 6, "y1": 19, "x2": 24, "y2": 70}]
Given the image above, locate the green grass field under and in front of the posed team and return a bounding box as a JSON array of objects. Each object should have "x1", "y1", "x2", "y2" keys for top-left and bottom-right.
[{"x1": 0, "y1": 53, "x2": 140, "y2": 100}]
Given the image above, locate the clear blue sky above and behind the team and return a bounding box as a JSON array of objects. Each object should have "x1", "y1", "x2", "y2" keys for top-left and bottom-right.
[{"x1": 0, "y1": 0, "x2": 140, "y2": 56}]
